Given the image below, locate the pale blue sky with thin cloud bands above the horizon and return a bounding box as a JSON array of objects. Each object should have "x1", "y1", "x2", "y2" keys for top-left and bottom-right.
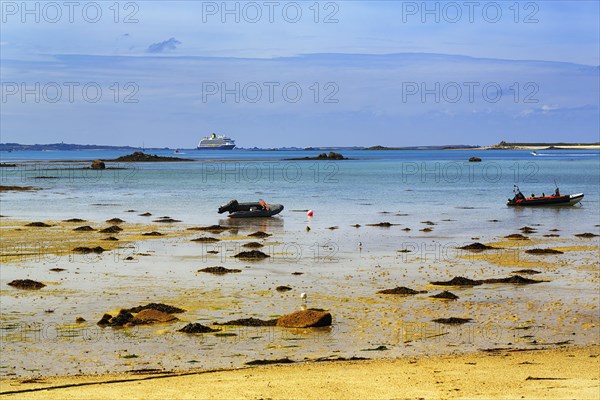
[{"x1": 0, "y1": 1, "x2": 600, "y2": 148}]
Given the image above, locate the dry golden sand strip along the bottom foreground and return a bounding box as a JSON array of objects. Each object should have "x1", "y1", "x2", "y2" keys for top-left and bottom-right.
[{"x1": 0, "y1": 346, "x2": 600, "y2": 400}]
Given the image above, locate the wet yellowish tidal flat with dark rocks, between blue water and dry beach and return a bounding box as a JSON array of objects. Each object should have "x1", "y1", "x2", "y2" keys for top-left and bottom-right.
[{"x1": 0, "y1": 213, "x2": 599, "y2": 384}]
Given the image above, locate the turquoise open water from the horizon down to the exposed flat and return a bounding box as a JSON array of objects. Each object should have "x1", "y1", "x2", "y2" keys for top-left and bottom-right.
[{"x1": 0, "y1": 150, "x2": 600, "y2": 233}]
